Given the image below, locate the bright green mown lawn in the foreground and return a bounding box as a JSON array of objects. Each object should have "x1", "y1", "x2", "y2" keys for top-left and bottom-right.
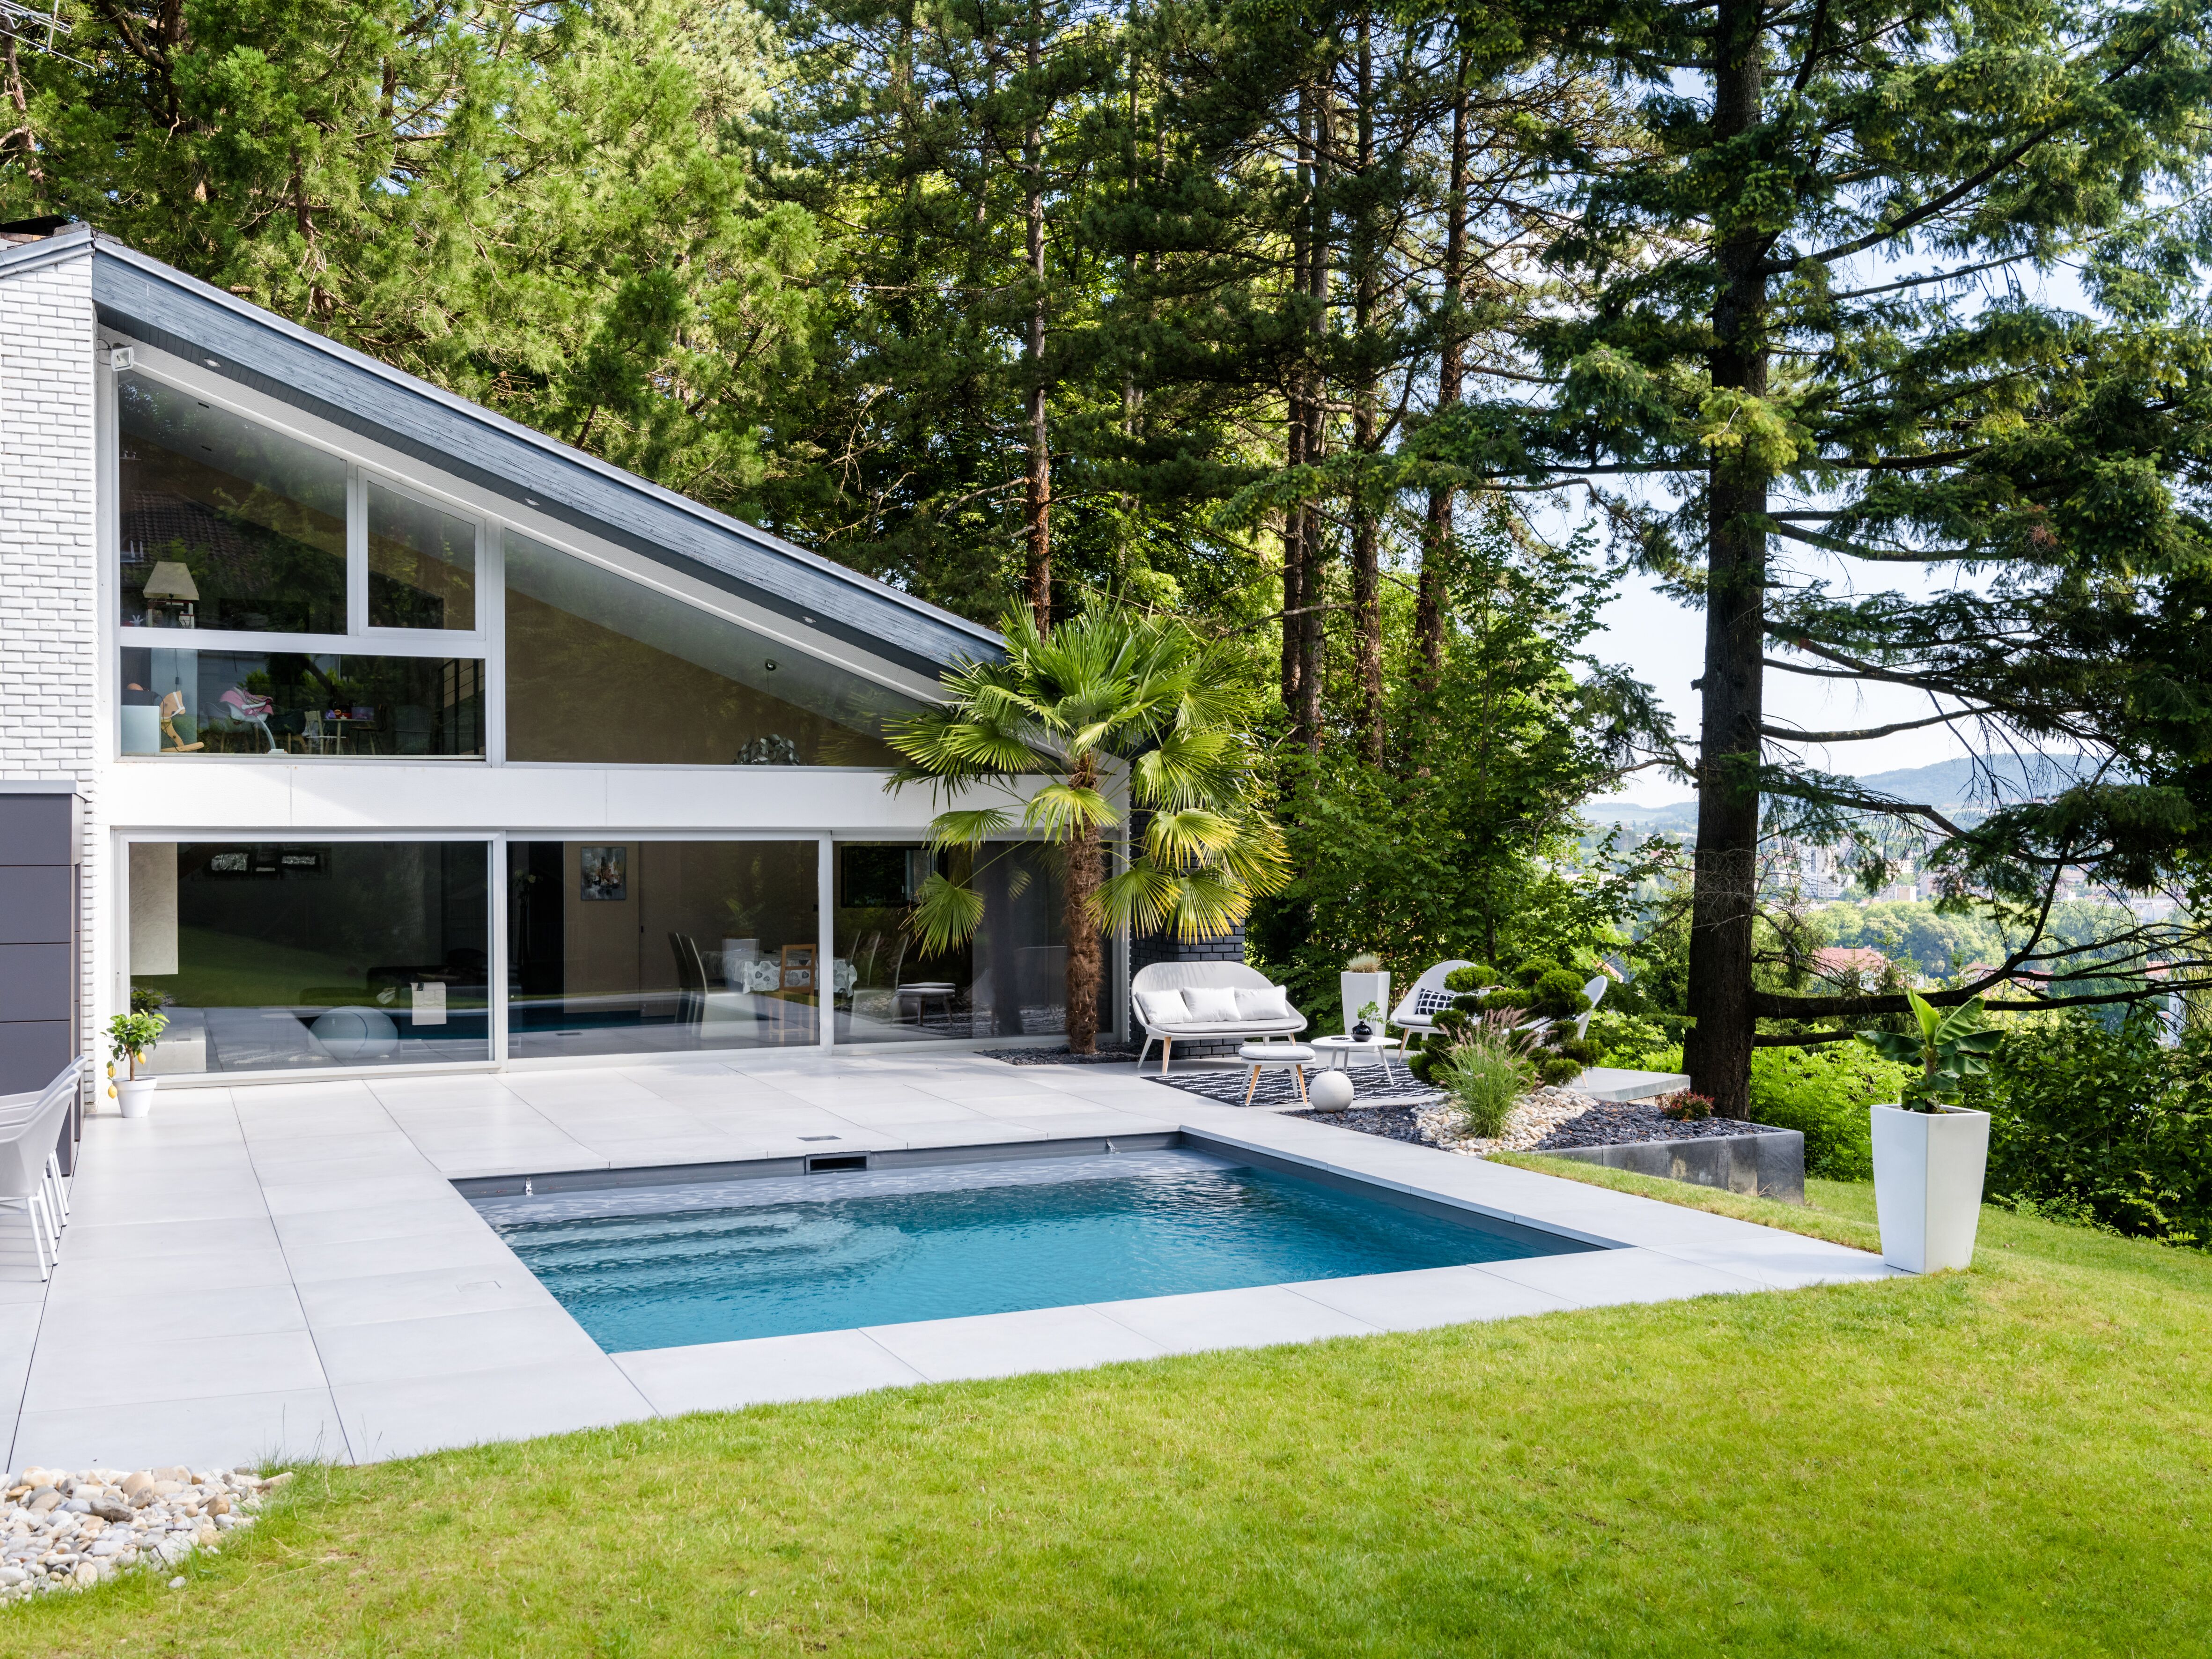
[{"x1": 17, "y1": 1183, "x2": 2212, "y2": 1657}]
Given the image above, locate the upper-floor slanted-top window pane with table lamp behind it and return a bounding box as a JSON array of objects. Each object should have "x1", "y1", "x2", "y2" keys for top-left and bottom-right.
[{"x1": 115, "y1": 374, "x2": 345, "y2": 633}]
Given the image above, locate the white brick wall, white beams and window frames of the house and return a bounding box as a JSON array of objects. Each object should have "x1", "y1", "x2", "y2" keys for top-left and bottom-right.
[{"x1": 0, "y1": 235, "x2": 1106, "y2": 1086}]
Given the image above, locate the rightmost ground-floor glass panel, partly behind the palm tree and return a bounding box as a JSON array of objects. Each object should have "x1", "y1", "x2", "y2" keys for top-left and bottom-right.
[{"x1": 832, "y1": 843, "x2": 1069, "y2": 1042}]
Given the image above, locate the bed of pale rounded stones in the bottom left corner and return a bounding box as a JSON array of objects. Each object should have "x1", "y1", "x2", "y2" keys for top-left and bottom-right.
[{"x1": 0, "y1": 1467, "x2": 292, "y2": 1604}]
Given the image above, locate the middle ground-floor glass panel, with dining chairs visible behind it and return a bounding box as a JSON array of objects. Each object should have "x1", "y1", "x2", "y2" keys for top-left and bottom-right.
[{"x1": 507, "y1": 841, "x2": 821, "y2": 1060}]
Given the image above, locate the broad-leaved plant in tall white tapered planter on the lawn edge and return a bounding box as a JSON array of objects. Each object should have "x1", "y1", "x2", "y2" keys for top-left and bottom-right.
[{"x1": 1858, "y1": 991, "x2": 2004, "y2": 1274}]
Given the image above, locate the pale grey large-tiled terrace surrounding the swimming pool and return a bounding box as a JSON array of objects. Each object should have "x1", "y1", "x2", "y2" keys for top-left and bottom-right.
[{"x1": 0, "y1": 1051, "x2": 1895, "y2": 1469}]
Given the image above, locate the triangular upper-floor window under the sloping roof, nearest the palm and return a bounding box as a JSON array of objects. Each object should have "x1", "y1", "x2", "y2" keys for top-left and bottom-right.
[{"x1": 507, "y1": 531, "x2": 914, "y2": 767}]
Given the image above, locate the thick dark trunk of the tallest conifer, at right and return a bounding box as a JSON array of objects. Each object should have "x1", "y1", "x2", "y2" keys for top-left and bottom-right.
[{"x1": 1683, "y1": 0, "x2": 1767, "y2": 1117}]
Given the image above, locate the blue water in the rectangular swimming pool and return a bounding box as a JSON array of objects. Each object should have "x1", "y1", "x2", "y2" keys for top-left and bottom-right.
[{"x1": 473, "y1": 1150, "x2": 1588, "y2": 1354}]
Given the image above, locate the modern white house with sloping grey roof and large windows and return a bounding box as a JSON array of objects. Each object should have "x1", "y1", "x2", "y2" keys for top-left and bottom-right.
[{"x1": 0, "y1": 223, "x2": 1128, "y2": 1106}]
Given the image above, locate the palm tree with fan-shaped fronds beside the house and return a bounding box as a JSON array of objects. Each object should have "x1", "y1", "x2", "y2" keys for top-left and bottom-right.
[{"x1": 885, "y1": 602, "x2": 1290, "y2": 1055}]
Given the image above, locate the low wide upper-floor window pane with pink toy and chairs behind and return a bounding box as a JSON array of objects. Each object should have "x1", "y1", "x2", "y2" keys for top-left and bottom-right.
[{"x1": 117, "y1": 646, "x2": 485, "y2": 757}]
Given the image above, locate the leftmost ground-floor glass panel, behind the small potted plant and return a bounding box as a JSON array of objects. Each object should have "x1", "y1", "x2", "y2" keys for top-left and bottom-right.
[{"x1": 131, "y1": 841, "x2": 491, "y2": 1073}]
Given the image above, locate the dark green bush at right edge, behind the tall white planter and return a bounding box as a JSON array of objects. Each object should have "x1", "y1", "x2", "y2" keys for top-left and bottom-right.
[{"x1": 1967, "y1": 1013, "x2": 2212, "y2": 1246}]
